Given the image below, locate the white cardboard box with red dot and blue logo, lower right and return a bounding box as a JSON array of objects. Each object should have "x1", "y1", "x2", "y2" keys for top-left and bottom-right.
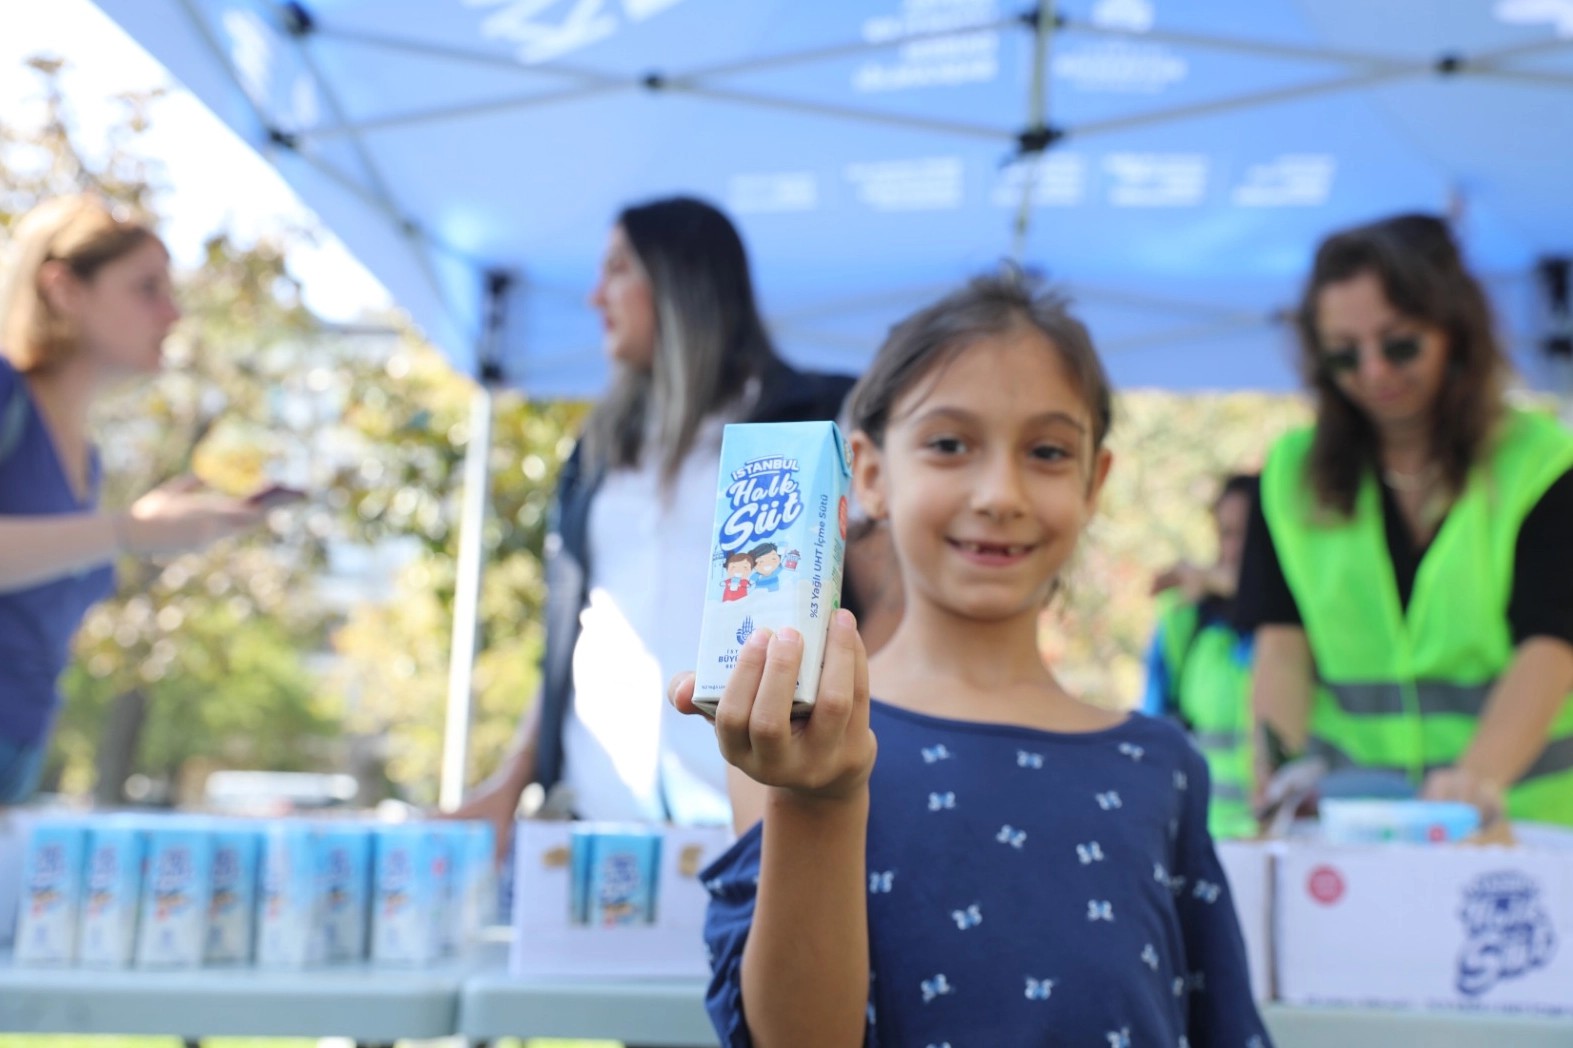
[{"x1": 1276, "y1": 843, "x2": 1573, "y2": 1012}]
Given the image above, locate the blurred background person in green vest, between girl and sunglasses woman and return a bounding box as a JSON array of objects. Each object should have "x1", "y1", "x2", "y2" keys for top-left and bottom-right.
[{"x1": 1142, "y1": 474, "x2": 1258, "y2": 837}]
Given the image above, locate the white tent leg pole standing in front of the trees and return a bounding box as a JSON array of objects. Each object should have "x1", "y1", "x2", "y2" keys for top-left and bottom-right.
[{"x1": 437, "y1": 382, "x2": 492, "y2": 812}]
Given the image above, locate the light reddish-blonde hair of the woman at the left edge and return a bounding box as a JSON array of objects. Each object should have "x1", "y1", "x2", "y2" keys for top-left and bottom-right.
[{"x1": 0, "y1": 195, "x2": 159, "y2": 373}]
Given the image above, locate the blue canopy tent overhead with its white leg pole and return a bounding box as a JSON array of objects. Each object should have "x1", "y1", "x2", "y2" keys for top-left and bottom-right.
[{"x1": 99, "y1": 0, "x2": 1573, "y2": 803}]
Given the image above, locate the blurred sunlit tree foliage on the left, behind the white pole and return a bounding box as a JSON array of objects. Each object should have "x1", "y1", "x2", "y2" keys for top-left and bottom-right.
[{"x1": 0, "y1": 58, "x2": 579, "y2": 801}]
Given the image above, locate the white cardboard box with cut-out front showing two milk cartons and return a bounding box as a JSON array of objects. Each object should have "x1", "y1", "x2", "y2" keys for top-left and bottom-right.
[{"x1": 508, "y1": 821, "x2": 731, "y2": 979}]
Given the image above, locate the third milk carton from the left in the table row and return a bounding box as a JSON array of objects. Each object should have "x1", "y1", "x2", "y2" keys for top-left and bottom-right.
[{"x1": 137, "y1": 818, "x2": 212, "y2": 968}]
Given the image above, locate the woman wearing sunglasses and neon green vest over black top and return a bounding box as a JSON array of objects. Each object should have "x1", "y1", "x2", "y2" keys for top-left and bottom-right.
[{"x1": 1238, "y1": 216, "x2": 1573, "y2": 825}]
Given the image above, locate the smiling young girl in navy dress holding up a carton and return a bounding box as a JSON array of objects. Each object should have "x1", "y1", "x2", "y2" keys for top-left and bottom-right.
[{"x1": 672, "y1": 279, "x2": 1268, "y2": 1048}]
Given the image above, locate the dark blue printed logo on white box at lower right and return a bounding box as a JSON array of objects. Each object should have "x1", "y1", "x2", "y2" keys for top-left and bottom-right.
[{"x1": 1458, "y1": 870, "x2": 1557, "y2": 998}]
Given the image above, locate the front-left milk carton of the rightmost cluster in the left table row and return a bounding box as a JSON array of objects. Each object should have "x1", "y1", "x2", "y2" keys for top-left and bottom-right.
[{"x1": 371, "y1": 823, "x2": 453, "y2": 965}]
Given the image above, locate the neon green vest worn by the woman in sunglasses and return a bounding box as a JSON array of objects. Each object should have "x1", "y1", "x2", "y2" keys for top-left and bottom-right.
[{"x1": 1262, "y1": 409, "x2": 1573, "y2": 825}]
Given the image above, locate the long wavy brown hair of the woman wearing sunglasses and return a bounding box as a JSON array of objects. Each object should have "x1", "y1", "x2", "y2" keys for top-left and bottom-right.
[{"x1": 1296, "y1": 214, "x2": 1509, "y2": 516}]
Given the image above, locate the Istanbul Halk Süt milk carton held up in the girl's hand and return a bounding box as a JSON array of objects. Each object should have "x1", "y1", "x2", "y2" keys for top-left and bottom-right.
[{"x1": 694, "y1": 422, "x2": 851, "y2": 716}]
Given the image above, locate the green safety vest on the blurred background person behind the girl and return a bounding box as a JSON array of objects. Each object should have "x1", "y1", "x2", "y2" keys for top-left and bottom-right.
[{"x1": 1158, "y1": 593, "x2": 1257, "y2": 837}]
